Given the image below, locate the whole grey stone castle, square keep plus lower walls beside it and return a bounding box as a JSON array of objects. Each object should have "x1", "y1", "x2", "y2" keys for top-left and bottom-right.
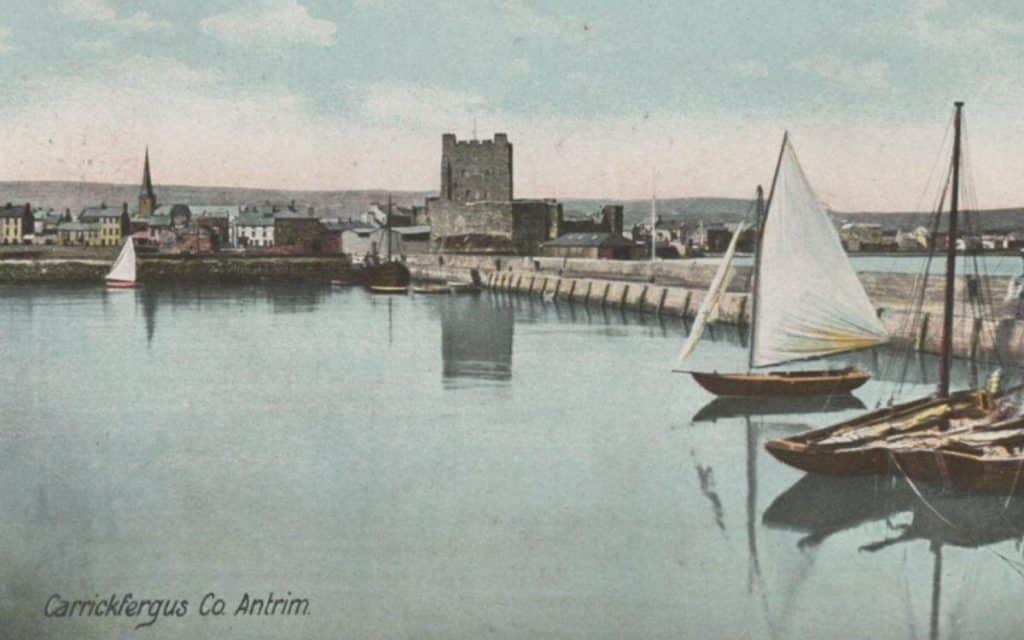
[{"x1": 426, "y1": 133, "x2": 562, "y2": 255}]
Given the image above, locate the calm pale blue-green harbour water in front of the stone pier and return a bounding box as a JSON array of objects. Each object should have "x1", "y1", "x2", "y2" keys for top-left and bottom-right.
[{"x1": 0, "y1": 287, "x2": 1024, "y2": 639}]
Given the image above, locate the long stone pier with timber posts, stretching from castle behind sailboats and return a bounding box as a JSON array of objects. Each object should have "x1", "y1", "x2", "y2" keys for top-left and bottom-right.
[{"x1": 409, "y1": 256, "x2": 1024, "y2": 361}]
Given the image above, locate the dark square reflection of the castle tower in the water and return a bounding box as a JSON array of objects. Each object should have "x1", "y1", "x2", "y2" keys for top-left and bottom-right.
[{"x1": 437, "y1": 296, "x2": 515, "y2": 380}]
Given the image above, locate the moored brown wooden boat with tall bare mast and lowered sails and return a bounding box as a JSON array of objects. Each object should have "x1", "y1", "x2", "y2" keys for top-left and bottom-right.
[{"x1": 765, "y1": 101, "x2": 1024, "y2": 493}]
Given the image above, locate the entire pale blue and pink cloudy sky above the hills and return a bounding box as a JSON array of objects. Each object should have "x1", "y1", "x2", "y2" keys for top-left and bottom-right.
[{"x1": 0, "y1": 0, "x2": 1024, "y2": 210}]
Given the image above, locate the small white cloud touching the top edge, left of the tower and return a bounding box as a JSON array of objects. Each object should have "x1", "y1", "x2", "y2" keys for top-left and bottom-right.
[{"x1": 200, "y1": 0, "x2": 338, "y2": 47}]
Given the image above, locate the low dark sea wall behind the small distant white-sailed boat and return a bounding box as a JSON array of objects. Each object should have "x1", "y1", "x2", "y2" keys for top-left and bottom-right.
[{"x1": 0, "y1": 257, "x2": 352, "y2": 285}]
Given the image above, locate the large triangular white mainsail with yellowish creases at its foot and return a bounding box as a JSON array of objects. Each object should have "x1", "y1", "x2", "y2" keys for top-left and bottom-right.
[{"x1": 751, "y1": 138, "x2": 888, "y2": 367}]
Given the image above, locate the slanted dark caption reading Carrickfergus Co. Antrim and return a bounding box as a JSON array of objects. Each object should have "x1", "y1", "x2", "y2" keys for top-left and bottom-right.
[{"x1": 43, "y1": 591, "x2": 309, "y2": 629}]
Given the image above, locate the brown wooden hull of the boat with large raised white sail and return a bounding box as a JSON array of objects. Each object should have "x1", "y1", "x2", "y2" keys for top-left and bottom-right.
[{"x1": 690, "y1": 369, "x2": 870, "y2": 397}]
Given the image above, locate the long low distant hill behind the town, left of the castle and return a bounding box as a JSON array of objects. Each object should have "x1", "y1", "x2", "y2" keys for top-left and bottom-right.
[{"x1": 0, "y1": 181, "x2": 436, "y2": 217}]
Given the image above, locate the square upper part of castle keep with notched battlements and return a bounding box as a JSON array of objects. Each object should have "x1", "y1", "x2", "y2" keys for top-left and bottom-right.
[{"x1": 441, "y1": 133, "x2": 512, "y2": 203}]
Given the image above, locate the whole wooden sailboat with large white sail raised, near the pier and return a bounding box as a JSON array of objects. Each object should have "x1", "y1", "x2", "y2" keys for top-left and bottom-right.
[{"x1": 676, "y1": 133, "x2": 888, "y2": 396}]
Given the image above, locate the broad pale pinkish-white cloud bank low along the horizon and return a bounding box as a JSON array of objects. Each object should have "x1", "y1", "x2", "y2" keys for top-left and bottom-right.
[{"x1": 6, "y1": 56, "x2": 1024, "y2": 211}]
